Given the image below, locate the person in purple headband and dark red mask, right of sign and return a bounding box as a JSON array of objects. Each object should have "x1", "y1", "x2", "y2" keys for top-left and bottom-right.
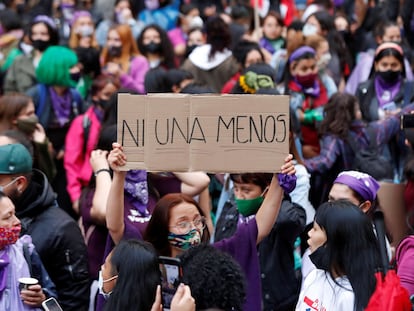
[{"x1": 285, "y1": 46, "x2": 336, "y2": 158}]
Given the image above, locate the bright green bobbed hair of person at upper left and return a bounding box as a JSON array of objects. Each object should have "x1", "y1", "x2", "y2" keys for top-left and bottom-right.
[{"x1": 36, "y1": 46, "x2": 78, "y2": 87}]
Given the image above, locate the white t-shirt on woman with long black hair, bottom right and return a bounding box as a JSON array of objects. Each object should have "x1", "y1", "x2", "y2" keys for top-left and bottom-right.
[{"x1": 296, "y1": 269, "x2": 355, "y2": 311}]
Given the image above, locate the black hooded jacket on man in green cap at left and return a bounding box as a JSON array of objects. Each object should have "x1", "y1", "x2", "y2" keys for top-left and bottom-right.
[{"x1": 14, "y1": 170, "x2": 90, "y2": 311}]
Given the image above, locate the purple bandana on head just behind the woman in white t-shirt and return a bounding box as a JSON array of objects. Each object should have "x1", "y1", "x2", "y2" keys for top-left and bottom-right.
[{"x1": 334, "y1": 171, "x2": 380, "y2": 202}]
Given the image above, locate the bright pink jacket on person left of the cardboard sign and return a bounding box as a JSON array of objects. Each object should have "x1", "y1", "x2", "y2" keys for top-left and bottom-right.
[{"x1": 64, "y1": 106, "x2": 101, "y2": 202}]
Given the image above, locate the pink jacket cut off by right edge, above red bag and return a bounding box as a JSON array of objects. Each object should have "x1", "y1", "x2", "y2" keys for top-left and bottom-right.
[{"x1": 395, "y1": 235, "x2": 414, "y2": 296}]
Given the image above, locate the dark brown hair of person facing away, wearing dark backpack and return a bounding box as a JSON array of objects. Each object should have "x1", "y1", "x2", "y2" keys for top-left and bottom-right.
[{"x1": 319, "y1": 93, "x2": 359, "y2": 139}]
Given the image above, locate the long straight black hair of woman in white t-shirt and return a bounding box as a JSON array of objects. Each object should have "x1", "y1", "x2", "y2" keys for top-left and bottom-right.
[{"x1": 315, "y1": 200, "x2": 379, "y2": 310}]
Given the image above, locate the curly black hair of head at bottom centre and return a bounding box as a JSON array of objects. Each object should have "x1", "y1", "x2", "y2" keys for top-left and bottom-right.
[{"x1": 180, "y1": 244, "x2": 246, "y2": 311}]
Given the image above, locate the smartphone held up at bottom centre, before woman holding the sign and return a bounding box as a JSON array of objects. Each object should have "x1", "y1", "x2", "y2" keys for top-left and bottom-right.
[{"x1": 158, "y1": 256, "x2": 183, "y2": 311}]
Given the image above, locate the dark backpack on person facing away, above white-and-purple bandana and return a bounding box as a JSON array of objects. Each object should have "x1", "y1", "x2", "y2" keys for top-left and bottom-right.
[{"x1": 347, "y1": 126, "x2": 394, "y2": 180}]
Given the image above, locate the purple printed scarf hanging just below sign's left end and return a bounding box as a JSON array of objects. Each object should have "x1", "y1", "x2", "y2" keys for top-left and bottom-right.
[{"x1": 124, "y1": 170, "x2": 149, "y2": 216}]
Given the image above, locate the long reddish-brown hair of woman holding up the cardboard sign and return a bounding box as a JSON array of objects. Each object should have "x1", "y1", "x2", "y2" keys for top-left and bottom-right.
[{"x1": 144, "y1": 193, "x2": 210, "y2": 256}]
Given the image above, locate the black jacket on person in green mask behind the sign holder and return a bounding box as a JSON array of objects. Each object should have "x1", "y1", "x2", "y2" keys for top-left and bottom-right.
[{"x1": 214, "y1": 197, "x2": 306, "y2": 311}]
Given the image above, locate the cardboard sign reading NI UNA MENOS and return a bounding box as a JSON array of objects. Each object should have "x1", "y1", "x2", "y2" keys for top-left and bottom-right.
[{"x1": 118, "y1": 94, "x2": 289, "y2": 173}]
